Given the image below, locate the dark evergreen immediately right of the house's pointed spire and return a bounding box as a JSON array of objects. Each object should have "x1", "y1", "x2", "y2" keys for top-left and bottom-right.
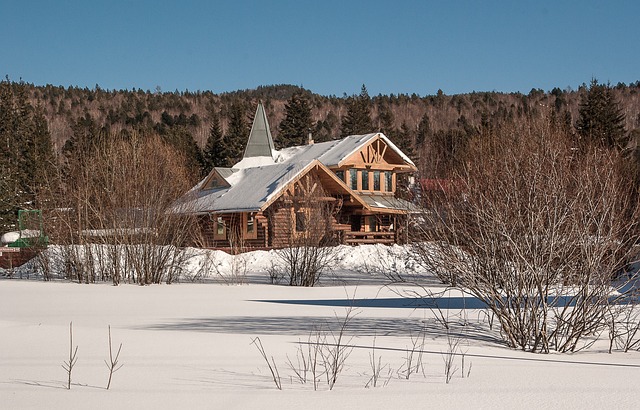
[{"x1": 275, "y1": 93, "x2": 314, "y2": 148}]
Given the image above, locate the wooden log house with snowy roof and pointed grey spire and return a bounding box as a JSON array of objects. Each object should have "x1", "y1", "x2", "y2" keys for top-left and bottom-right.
[{"x1": 176, "y1": 104, "x2": 416, "y2": 251}]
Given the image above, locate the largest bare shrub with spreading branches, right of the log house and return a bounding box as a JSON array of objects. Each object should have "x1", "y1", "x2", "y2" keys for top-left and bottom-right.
[{"x1": 414, "y1": 115, "x2": 639, "y2": 352}]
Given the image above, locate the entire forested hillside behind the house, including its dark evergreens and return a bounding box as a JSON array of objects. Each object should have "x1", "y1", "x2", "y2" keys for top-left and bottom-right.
[{"x1": 0, "y1": 79, "x2": 640, "y2": 231}]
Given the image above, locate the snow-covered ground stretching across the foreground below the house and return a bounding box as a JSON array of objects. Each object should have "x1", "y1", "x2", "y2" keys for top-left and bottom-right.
[{"x1": 0, "y1": 247, "x2": 640, "y2": 409}]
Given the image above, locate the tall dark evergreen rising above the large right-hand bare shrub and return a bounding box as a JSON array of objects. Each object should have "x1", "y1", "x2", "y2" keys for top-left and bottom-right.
[{"x1": 576, "y1": 79, "x2": 627, "y2": 148}]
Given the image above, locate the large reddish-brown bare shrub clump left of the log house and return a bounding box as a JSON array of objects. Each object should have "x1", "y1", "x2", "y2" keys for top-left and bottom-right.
[{"x1": 41, "y1": 134, "x2": 194, "y2": 285}]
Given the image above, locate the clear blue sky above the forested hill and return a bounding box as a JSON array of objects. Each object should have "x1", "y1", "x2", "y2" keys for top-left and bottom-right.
[{"x1": 0, "y1": 0, "x2": 640, "y2": 96}]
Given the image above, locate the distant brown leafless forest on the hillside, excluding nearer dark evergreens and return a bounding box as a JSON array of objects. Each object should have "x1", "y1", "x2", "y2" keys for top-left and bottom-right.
[{"x1": 12, "y1": 81, "x2": 640, "y2": 168}]
